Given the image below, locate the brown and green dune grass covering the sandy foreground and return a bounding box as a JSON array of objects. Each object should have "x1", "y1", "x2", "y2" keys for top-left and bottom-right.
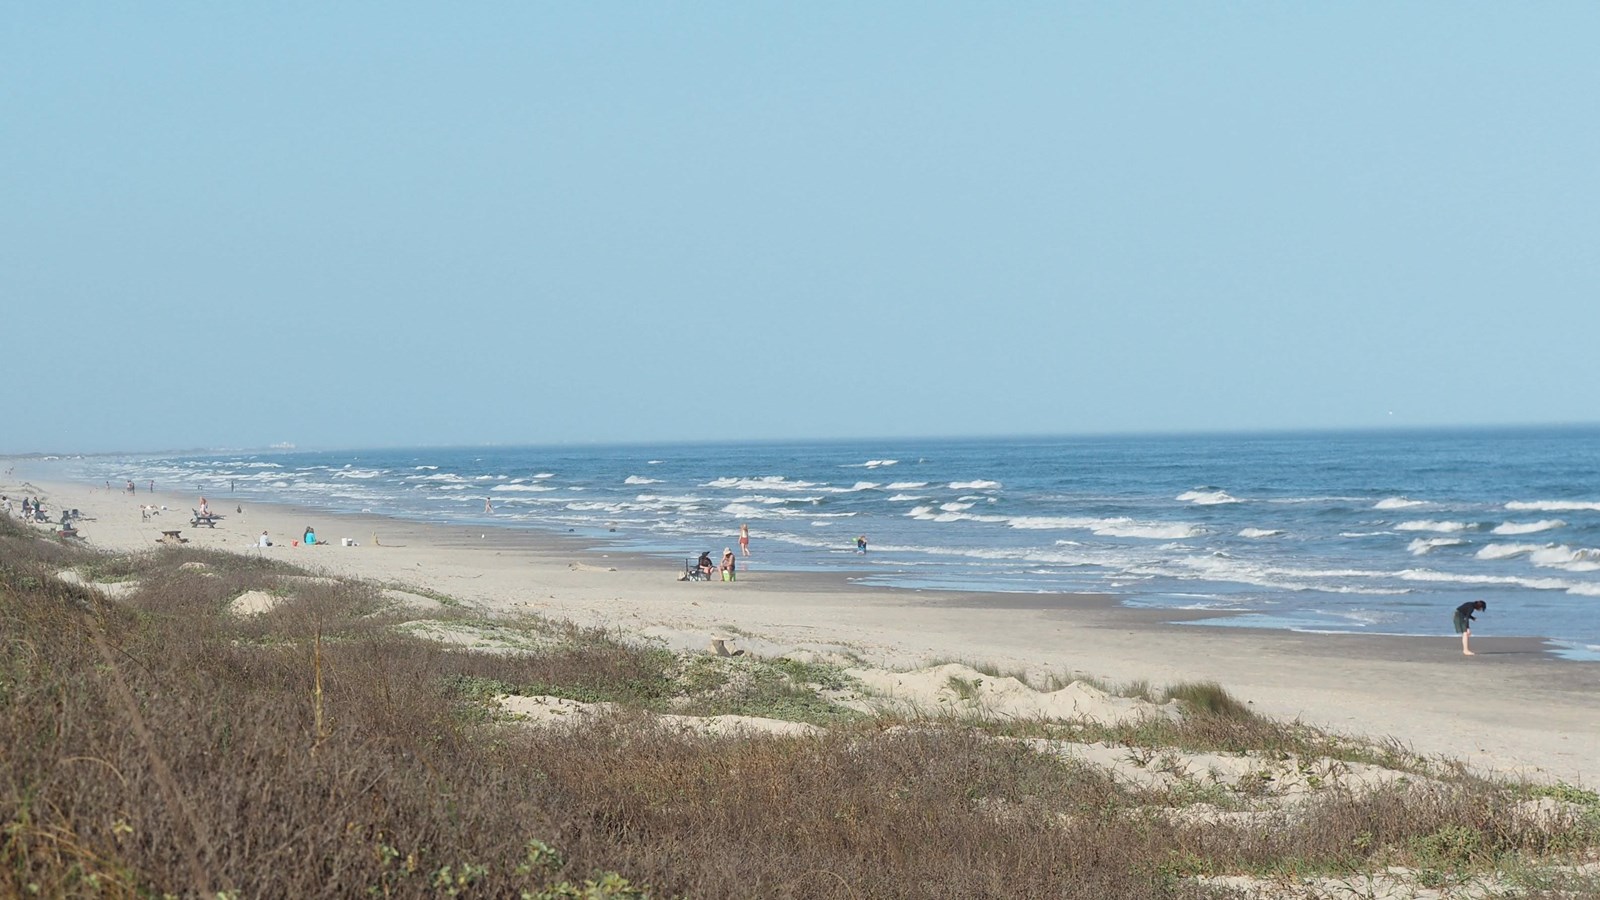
[{"x1": 0, "y1": 520, "x2": 1600, "y2": 898}]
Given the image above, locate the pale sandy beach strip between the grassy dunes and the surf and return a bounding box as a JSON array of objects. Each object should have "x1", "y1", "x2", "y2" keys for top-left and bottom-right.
[{"x1": 12, "y1": 460, "x2": 1600, "y2": 788}]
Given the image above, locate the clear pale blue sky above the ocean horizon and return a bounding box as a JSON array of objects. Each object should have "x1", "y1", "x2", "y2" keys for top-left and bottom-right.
[{"x1": 0, "y1": 0, "x2": 1600, "y2": 452}]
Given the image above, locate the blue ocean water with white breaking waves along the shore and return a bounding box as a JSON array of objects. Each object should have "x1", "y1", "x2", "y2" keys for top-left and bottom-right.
[{"x1": 56, "y1": 428, "x2": 1600, "y2": 660}]
